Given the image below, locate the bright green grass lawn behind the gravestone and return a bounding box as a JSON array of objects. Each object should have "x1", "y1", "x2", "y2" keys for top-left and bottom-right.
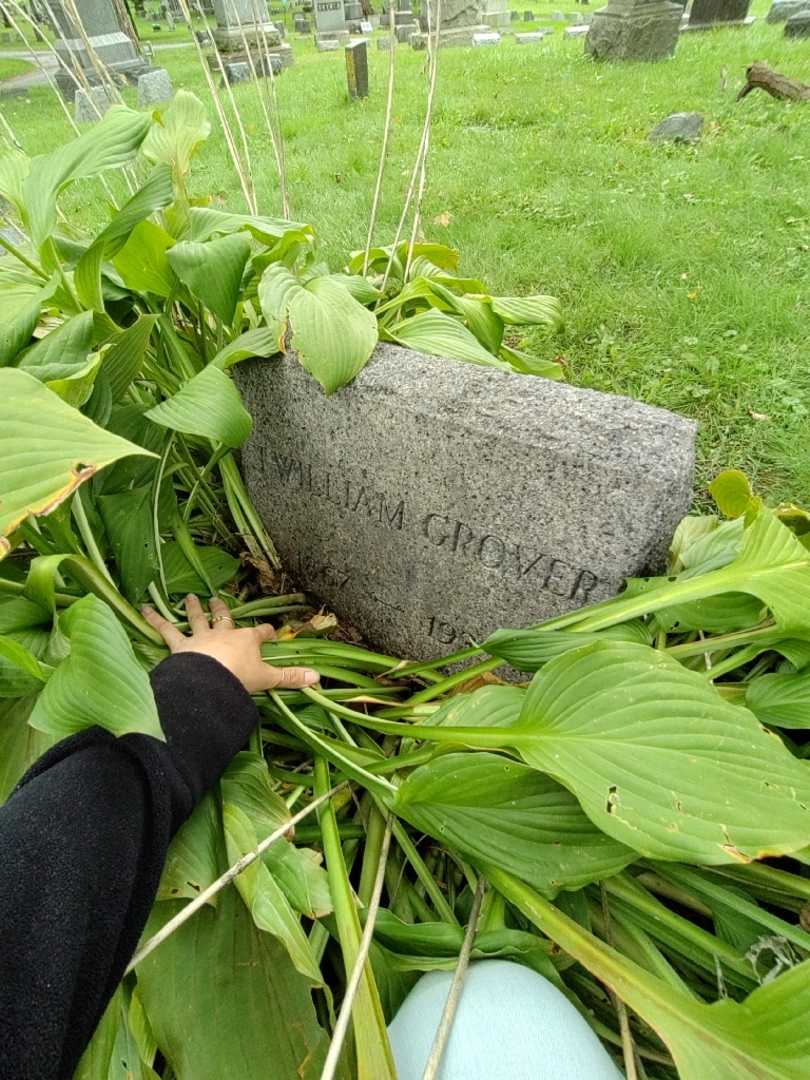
[{"x1": 0, "y1": 9, "x2": 810, "y2": 501}]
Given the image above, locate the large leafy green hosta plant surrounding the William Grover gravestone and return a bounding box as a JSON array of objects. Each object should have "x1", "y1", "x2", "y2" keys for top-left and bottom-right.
[{"x1": 0, "y1": 88, "x2": 810, "y2": 1080}]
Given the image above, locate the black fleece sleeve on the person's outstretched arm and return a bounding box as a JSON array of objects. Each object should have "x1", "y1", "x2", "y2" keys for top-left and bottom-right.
[{"x1": 0, "y1": 652, "x2": 258, "y2": 1080}]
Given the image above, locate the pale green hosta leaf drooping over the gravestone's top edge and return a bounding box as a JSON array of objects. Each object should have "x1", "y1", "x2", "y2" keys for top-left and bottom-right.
[{"x1": 259, "y1": 264, "x2": 377, "y2": 394}]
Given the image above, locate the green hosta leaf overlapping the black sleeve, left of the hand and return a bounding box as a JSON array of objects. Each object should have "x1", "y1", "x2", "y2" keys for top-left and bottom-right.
[{"x1": 30, "y1": 595, "x2": 163, "y2": 740}]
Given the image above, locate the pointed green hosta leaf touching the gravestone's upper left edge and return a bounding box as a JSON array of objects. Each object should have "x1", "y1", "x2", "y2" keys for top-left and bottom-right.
[{"x1": 146, "y1": 364, "x2": 253, "y2": 446}]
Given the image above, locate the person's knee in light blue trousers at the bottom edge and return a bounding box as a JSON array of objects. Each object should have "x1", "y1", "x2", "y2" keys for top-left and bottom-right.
[{"x1": 389, "y1": 960, "x2": 621, "y2": 1080}]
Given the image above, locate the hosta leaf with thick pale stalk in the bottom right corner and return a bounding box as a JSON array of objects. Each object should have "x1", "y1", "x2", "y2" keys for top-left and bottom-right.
[{"x1": 488, "y1": 867, "x2": 810, "y2": 1080}]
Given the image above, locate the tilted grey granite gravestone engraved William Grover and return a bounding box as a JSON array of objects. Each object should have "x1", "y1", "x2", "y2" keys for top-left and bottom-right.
[{"x1": 237, "y1": 345, "x2": 694, "y2": 659}]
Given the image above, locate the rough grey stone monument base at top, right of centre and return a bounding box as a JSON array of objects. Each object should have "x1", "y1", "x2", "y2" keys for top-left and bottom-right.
[{"x1": 583, "y1": 0, "x2": 684, "y2": 60}]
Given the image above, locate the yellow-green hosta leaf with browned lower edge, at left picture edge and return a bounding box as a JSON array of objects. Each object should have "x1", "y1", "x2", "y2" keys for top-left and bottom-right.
[{"x1": 0, "y1": 368, "x2": 154, "y2": 557}]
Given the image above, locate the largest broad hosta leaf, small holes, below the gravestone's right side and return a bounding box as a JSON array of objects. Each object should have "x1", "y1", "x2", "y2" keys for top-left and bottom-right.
[{"x1": 514, "y1": 642, "x2": 810, "y2": 865}]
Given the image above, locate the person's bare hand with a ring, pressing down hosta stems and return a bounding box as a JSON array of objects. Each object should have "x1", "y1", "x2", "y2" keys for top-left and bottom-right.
[{"x1": 143, "y1": 596, "x2": 320, "y2": 693}]
